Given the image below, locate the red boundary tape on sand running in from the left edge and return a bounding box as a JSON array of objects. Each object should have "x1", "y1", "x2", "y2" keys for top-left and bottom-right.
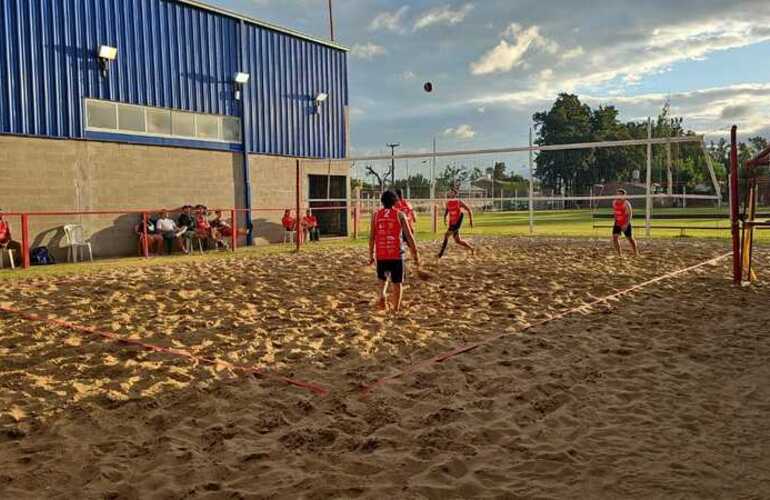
[{"x1": 0, "y1": 306, "x2": 329, "y2": 396}]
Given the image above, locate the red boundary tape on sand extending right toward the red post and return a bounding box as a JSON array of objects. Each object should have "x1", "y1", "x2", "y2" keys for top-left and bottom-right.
[{"x1": 361, "y1": 252, "x2": 732, "y2": 397}]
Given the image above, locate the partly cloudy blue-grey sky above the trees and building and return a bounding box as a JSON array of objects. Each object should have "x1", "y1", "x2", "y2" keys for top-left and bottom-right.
[{"x1": 206, "y1": 0, "x2": 770, "y2": 176}]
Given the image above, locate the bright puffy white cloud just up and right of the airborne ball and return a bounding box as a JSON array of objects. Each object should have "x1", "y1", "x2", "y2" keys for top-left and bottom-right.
[{"x1": 471, "y1": 23, "x2": 558, "y2": 75}]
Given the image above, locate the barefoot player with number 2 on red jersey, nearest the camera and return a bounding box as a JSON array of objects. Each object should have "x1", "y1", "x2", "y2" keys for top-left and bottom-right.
[{"x1": 369, "y1": 191, "x2": 420, "y2": 312}]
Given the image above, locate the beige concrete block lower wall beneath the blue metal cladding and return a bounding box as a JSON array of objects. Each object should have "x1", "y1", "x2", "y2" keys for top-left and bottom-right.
[{"x1": 0, "y1": 136, "x2": 348, "y2": 261}]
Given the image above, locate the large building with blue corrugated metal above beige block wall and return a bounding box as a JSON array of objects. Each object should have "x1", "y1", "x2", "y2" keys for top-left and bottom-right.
[{"x1": 0, "y1": 0, "x2": 350, "y2": 257}]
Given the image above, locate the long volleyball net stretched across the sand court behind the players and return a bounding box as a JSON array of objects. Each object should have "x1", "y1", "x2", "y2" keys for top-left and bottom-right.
[{"x1": 349, "y1": 136, "x2": 731, "y2": 236}]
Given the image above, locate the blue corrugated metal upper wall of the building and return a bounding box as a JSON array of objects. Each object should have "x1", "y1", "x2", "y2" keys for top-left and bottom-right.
[{"x1": 0, "y1": 0, "x2": 347, "y2": 158}]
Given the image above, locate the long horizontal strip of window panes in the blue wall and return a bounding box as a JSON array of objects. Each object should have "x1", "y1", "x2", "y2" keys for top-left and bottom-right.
[{"x1": 85, "y1": 99, "x2": 241, "y2": 143}]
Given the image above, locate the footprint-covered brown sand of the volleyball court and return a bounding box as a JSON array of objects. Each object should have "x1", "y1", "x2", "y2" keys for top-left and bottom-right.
[{"x1": 0, "y1": 239, "x2": 770, "y2": 498}]
